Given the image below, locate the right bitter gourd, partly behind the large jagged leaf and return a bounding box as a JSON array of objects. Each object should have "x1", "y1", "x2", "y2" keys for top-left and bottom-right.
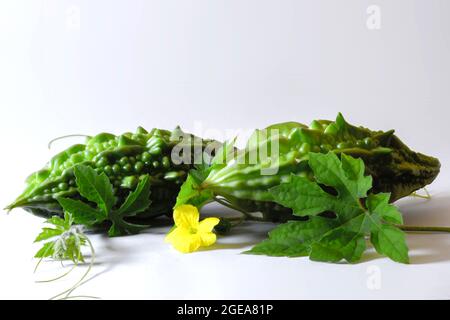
[{"x1": 200, "y1": 114, "x2": 440, "y2": 221}]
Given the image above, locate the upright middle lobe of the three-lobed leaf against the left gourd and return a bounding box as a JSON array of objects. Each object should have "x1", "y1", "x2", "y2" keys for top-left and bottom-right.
[{"x1": 74, "y1": 165, "x2": 116, "y2": 213}]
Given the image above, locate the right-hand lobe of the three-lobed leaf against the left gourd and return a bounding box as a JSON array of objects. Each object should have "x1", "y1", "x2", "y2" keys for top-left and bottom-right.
[{"x1": 117, "y1": 175, "x2": 151, "y2": 217}]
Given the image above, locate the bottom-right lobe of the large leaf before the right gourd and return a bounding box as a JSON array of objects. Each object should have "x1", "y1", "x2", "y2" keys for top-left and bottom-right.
[{"x1": 370, "y1": 224, "x2": 409, "y2": 263}]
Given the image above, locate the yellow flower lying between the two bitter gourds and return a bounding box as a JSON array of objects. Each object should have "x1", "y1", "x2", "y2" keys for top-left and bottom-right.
[{"x1": 166, "y1": 205, "x2": 220, "y2": 253}]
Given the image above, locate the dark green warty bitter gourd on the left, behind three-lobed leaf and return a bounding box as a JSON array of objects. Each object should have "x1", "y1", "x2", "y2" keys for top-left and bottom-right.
[{"x1": 7, "y1": 127, "x2": 217, "y2": 218}]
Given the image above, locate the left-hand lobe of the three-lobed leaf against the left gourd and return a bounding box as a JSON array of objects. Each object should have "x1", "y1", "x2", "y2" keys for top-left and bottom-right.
[{"x1": 57, "y1": 198, "x2": 104, "y2": 227}]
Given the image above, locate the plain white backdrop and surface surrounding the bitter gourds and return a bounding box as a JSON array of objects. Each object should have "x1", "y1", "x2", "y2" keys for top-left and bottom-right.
[{"x1": 0, "y1": 0, "x2": 450, "y2": 299}]
